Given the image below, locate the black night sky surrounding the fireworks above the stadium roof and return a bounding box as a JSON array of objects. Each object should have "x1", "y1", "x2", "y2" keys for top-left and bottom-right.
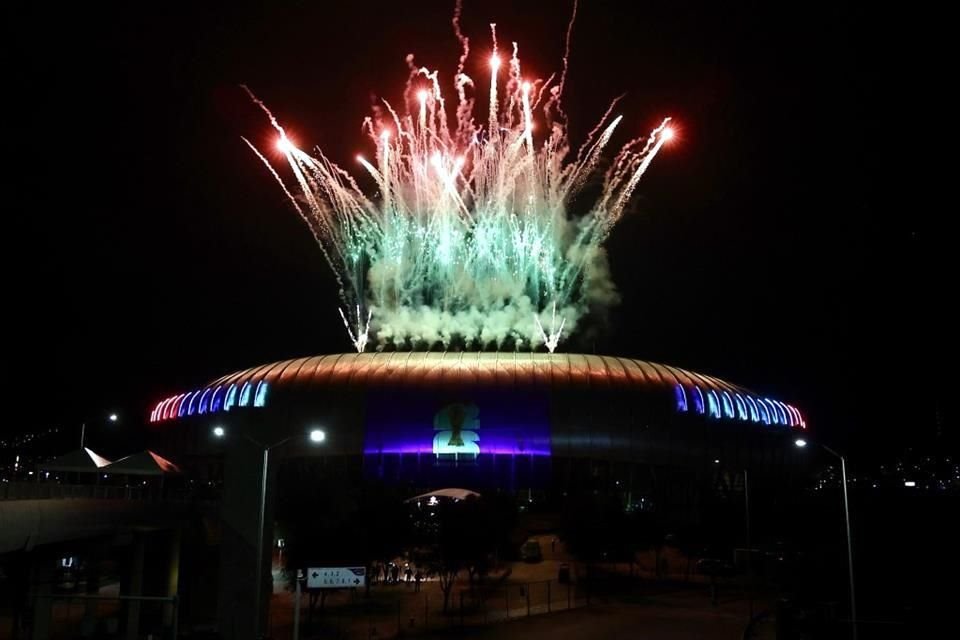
[{"x1": 0, "y1": 0, "x2": 936, "y2": 455}]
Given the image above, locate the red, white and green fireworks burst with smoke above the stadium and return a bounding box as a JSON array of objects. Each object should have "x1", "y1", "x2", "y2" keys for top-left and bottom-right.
[{"x1": 247, "y1": 12, "x2": 672, "y2": 352}]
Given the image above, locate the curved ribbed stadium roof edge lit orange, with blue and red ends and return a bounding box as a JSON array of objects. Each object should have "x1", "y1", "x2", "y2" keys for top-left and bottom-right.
[{"x1": 150, "y1": 351, "x2": 806, "y2": 429}]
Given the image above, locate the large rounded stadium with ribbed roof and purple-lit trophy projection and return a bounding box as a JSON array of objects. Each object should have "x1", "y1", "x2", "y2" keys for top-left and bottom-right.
[{"x1": 150, "y1": 352, "x2": 806, "y2": 508}]
